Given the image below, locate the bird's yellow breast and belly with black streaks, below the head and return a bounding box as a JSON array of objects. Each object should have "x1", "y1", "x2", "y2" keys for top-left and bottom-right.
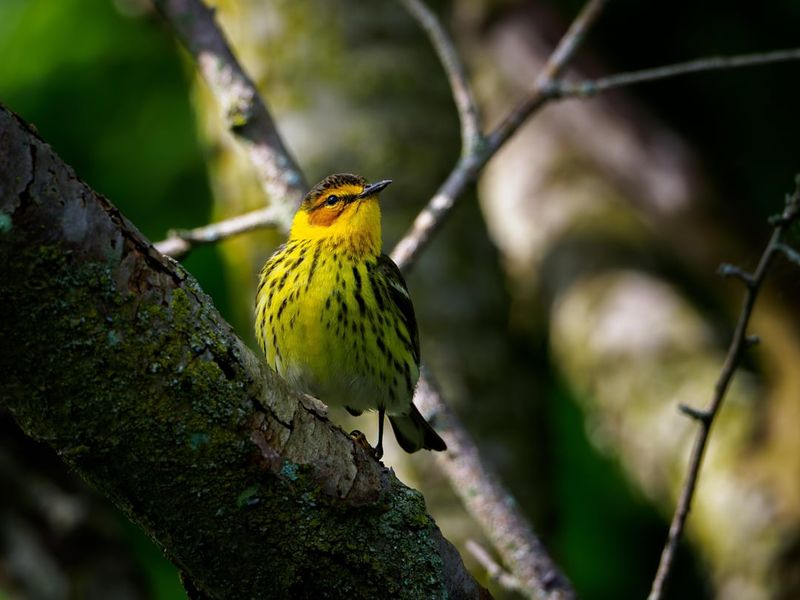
[{"x1": 256, "y1": 233, "x2": 418, "y2": 414}]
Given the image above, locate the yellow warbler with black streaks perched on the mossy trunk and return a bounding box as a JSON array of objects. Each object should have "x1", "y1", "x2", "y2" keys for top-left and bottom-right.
[{"x1": 256, "y1": 174, "x2": 446, "y2": 458}]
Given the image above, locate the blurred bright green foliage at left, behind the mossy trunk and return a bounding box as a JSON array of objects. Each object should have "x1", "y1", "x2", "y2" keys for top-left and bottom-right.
[{"x1": 0, "y1": 0, "x2": 219, "y2": 600}]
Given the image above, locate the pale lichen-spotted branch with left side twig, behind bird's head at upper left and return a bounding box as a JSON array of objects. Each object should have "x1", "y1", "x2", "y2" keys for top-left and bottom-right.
[{"x1": 154, "y1": 0, "x2": 308, "y2": 256}]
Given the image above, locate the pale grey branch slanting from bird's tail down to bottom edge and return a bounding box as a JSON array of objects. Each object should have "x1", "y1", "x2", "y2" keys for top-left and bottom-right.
[{"x1": 414, "y1": 373, "x2": 575, "y2": 600}]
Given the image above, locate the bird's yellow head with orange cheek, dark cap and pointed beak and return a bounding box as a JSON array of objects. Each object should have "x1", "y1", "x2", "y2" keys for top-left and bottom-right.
[{"x1": 290, "y1": 173, "x2": 392, "y2": 252}]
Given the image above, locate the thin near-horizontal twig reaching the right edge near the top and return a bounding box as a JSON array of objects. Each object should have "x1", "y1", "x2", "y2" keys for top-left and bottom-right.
[{"x1": 551, "y1": 48, "x2": 800, "y2": 98}]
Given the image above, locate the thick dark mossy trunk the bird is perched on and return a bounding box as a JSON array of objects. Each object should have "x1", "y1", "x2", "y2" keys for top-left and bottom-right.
[{"x1": 0, "y1": 108, "x2": 485, "y2": 598}]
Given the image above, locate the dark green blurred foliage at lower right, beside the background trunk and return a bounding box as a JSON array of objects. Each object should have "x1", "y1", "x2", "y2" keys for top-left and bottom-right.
[{"x1": 550, "y1": 381, "x2": 711, "y2": 600}]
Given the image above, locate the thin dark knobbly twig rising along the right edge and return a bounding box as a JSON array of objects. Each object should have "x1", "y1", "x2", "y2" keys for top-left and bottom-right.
[{"x1": 648, "y1": 176, "x2": 800, "y2": 600}]
